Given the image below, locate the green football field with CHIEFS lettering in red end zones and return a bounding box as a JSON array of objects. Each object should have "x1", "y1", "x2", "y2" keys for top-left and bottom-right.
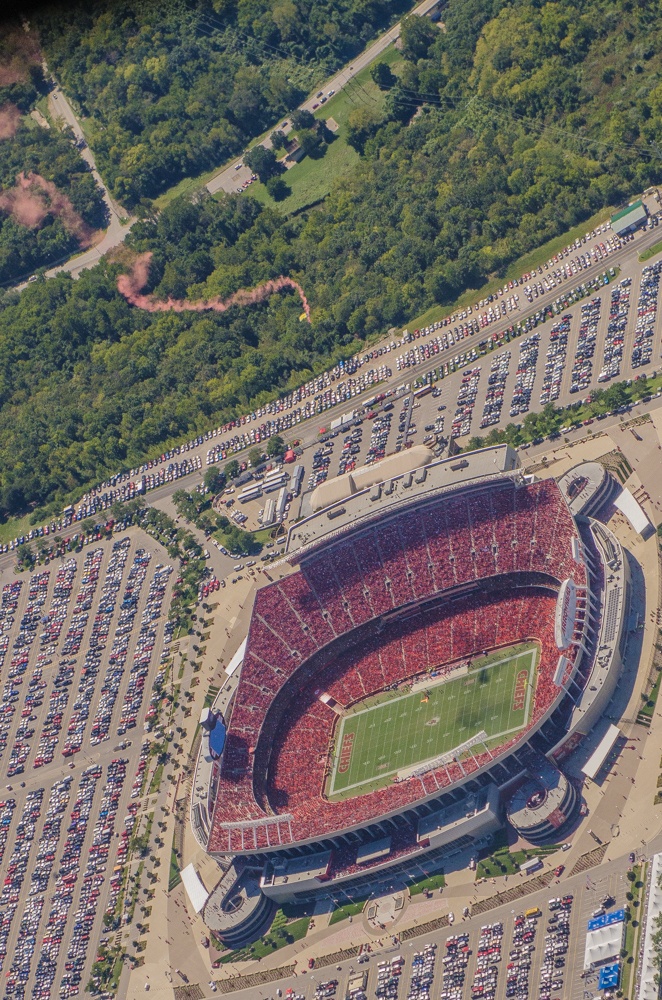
[{"x1": 327, "y1": 643, "x2": 539, "y2": 799}]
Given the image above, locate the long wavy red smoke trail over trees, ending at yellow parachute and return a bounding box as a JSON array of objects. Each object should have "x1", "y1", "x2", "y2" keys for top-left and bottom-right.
[{"x1": 117, "y1": 253, "x2": 310, "y2": 323}]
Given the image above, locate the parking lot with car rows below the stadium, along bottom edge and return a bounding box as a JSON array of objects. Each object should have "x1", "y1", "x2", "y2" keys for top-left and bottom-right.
[{"x1": 237, "y1": 855, "x2": 640, "y2": 1000}]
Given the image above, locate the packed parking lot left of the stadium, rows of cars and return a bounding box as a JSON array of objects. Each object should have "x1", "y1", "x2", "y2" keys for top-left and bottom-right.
[{"x1": 0, "y1": 530, "x2": 174, "y2": 1000}]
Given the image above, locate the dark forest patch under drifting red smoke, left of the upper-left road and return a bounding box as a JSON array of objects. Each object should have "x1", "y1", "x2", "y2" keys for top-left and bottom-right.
[{"x1": 0, "y1": 21, "x2": 106, "y2": 284}]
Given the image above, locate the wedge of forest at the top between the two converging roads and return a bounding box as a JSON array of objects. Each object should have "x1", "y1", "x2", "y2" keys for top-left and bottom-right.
[{"x1": 35, "y1": 0, "x2": 416, "y2": 208}]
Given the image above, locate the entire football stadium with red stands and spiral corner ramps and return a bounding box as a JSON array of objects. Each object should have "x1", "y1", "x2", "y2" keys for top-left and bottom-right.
[{"x1": 191, "y1": 445, "x2": 630, "y2": 944}]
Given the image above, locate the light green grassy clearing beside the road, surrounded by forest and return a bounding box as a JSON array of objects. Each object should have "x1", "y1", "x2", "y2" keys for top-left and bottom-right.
[{"x1": 250, "y1": 45, "x2": 402, "y2": 215}]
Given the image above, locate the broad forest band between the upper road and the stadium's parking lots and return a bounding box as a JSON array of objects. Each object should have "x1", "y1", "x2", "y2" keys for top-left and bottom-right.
[{"x1": 0, "y1": 0, "x2": 662, "y2": 516}]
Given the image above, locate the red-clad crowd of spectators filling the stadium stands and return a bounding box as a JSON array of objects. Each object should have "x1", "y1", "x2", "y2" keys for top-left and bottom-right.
[{"x1": 210, "y1": 479, "x2": 585, "y2": 851}]
